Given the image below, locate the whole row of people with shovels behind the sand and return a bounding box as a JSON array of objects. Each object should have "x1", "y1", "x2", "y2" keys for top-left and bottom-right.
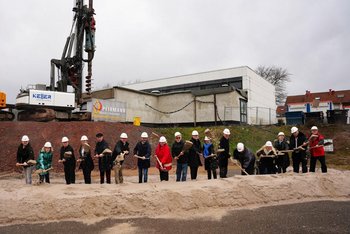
[{"x1": 17, "y1": 126, "x2": 327, "y2": 184}]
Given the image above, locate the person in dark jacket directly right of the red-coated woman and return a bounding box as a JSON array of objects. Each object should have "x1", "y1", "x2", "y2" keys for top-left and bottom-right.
[{"x1": 171, "y1": 132, "x2": 188, "y2": 182}]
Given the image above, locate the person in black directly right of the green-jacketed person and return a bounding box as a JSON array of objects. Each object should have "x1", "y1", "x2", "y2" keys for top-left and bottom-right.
[{"x1": 58, "y1": 137, "x2": 76, "y2": 184}]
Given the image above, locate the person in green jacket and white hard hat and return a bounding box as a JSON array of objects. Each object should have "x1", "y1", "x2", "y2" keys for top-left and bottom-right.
[{"x1": 36, "y1": 142, "x2": 53, "y2": 183}]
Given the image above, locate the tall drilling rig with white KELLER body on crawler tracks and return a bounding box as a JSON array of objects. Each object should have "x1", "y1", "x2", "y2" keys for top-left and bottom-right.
[{"x1": 16, "y1": 0, "x2": 96, "y2": 121}]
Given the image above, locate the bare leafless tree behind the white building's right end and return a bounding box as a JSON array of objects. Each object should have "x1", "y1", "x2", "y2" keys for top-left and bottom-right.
[{"x1": 255, "y1": 66, "x2": 291, "y2": 105}]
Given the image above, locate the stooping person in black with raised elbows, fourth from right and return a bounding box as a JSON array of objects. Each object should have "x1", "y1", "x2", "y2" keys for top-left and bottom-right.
[{"x1": 256, "y1": 141, "x2": 277, "y2": 174}]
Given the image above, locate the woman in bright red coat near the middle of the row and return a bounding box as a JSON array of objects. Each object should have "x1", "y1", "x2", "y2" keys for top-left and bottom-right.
[{"x1": 155, "y1": 136, "x2": 173, "y2": 181}]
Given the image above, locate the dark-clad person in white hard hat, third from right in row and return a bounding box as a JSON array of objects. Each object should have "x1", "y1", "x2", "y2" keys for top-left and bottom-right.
[{"x1": 273, "y1": 132, "x2": 290, "y2": 173}]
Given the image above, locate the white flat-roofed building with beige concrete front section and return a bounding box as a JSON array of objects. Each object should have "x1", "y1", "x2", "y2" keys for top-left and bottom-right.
[{"x1": 92, "y1": 66, "x2": 276, "y2": 125}]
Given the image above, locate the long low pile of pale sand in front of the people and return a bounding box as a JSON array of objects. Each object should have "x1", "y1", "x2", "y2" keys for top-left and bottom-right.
[{"x1": 0, "y1": 169, "x2": 350, "y2": 225}]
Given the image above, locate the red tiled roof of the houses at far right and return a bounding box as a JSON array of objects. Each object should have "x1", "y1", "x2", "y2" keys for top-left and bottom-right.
[{"x1": 286, "y1": 89, "x2": 350, "y2": 105}]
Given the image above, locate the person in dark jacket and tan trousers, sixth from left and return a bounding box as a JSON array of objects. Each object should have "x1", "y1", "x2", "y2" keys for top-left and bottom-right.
[{"x1": 112, "y1": 132, "x2": 130, "y2": 184}]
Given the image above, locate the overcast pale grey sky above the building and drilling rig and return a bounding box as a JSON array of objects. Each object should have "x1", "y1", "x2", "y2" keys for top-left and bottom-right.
[{"x1": 0, "y1": 0, "x2": 350, "y2": 103}]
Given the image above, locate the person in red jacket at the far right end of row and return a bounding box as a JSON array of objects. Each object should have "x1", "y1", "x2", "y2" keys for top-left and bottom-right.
[{"x1": 309, "y1": 126, "x2": 327, "y2": 173}]
